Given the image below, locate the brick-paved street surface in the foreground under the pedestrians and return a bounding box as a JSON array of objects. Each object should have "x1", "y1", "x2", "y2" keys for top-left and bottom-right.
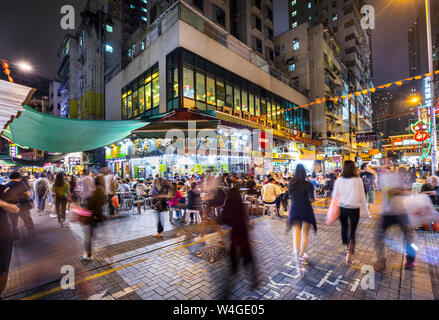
[{"x1": 4, "y1": 202, "x2": 439, "y2": 300}]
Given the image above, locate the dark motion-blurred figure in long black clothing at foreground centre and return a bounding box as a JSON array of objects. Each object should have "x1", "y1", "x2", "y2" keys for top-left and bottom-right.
[{"x1": 222, "y1": 187, "x2": 257, "y2": 299}]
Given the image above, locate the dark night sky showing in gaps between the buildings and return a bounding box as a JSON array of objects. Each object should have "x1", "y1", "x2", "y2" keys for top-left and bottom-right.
[{"x1": 0, "y1": 0, "x2": 421, "y2": 84}]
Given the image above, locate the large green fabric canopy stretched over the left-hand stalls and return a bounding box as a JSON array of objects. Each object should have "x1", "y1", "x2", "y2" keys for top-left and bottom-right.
[{"x1": 5, "y1": 106, "x2": 149, "y2": 153}]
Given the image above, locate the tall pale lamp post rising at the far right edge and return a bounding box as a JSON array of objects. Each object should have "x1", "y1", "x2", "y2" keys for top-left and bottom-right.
[{"x1": 425, "y1": 0, "x2": 437, "y2": 175}]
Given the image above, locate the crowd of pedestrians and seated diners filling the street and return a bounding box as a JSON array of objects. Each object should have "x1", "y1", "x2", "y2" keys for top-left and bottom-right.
[{"x1": 0, "y1": 160, "x2": 439, "y2": 298}]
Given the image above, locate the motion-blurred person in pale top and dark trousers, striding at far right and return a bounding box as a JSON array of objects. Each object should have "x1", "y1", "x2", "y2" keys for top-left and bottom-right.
[{"x1": 377, "y1": 168, "x2": 416, "y2": 270}]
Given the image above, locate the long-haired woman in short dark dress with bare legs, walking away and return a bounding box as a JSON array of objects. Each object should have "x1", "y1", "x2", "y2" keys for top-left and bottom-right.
[{"x1": 288, "y1": 164, "x2": 317, "y2": 263}]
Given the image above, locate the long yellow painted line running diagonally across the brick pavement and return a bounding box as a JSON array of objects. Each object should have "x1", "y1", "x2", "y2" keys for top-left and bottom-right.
[{"x1": 21, "y1": 216, "x2": 270, "y2": 300}]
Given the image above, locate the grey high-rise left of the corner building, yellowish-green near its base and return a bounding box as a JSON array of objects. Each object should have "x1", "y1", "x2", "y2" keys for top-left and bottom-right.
[{"x1": 52, "y1": 0, "x2": 122, "y2": 119}]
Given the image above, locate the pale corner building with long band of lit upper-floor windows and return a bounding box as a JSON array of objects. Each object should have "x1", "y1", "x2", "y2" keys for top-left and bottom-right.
[{"x1": 105, "y1": 0, "x2": 321, "y2": 177}]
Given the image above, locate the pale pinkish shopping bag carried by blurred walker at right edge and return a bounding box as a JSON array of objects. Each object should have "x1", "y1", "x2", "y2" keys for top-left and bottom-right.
[{"x1": 404, "y1": 193, "x2": 437, "y2": 227}]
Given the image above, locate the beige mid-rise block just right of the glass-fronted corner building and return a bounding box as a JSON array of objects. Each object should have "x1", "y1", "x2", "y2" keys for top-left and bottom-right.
[{"x1": 275, "y1": 22, "x2": 357, "y2": 164}]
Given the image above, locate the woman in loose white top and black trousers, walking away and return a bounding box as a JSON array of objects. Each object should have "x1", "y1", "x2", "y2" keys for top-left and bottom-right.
[{"x1": 332, "y1": 160, "x2": 369, "y2": 265}]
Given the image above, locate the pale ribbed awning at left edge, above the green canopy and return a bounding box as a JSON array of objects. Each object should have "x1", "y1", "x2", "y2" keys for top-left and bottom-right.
[{"x1": 0, "y1": 80, "x2": 35, "y2": 130}]
